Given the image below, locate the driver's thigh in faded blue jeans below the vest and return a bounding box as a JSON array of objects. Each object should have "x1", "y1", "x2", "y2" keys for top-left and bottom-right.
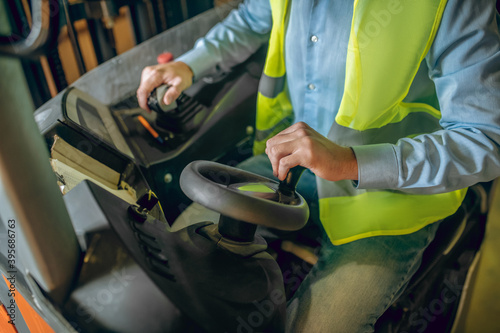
[{"x1": 287, "y1": 223, "x2": 439, "y2": 332}]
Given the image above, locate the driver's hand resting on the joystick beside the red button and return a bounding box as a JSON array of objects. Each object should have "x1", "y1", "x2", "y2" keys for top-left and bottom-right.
[{"x1": 137, "y1": 61, "x2": 193, "y2": 111}]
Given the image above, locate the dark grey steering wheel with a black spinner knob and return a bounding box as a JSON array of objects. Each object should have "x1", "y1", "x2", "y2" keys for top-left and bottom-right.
[{"x1": 180, "y1": 161, "x2": 309, "y2": 231}]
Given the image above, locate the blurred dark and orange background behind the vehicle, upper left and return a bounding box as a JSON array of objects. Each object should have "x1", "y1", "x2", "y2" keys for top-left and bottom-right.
[{"x1": 0, "y1": 0, "x2": 235, "y2": 111}]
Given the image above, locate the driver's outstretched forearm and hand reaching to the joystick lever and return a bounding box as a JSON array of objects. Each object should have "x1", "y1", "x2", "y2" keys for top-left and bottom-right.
[{"x1": 137, "y1": 0, "x2": 272, "y2": 110}]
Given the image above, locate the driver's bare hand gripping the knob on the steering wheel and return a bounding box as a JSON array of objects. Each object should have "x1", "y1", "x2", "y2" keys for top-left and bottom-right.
[{"x1": 266, "y1": 122, "x2": 358, "y2": 181}]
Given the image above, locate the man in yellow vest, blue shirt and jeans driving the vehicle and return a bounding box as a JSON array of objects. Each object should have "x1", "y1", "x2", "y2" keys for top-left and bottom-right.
[{"x1": 137, "y1": 0, "x2": 500, "y2": 332}]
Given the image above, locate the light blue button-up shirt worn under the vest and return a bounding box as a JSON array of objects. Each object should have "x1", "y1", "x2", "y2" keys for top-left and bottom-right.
[{"x1": 178, "y1": 0, "x2": 500, "y2": 194}]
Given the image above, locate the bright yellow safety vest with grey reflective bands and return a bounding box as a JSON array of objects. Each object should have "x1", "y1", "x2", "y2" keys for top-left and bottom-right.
[{"x1": 254, "y1": 0, "x2": 467, "y2": 245}]
